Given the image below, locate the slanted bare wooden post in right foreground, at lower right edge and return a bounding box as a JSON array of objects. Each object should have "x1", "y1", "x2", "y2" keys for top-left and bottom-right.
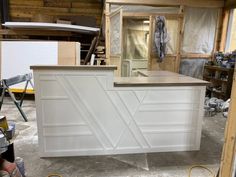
[{"x1": 220, "y1": 70, "x2": 236, "y2": 177}]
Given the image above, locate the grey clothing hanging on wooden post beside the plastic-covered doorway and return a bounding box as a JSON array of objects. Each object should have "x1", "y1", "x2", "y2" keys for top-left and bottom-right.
[{"x1": 154, "y1": 16, "x2": 169, "y2": 62}]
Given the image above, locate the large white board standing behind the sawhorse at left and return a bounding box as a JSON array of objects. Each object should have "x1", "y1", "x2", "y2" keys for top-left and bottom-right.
[{"x1": 0, "y1": 41, "x2": 58, "y2": 88}]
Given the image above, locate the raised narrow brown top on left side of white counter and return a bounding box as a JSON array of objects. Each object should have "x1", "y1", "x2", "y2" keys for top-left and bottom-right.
[{"x1": 30, "y1": 65, "x2": 117, "y2": 70}]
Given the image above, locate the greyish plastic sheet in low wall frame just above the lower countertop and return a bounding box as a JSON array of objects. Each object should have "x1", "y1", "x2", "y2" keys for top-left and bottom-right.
[{"x1": 179, "y1": 59, "x2": 207, "y2": 79}]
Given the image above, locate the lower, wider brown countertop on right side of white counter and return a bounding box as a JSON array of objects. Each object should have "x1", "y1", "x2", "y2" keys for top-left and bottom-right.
[{"x1": 114, "y1": 71, "x2": 209, "y2": 87}]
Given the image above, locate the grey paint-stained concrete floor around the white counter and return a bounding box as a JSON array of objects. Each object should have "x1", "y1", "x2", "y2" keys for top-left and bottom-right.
[{"x1": 0, "y1": 99, "x2": 226, "y2": 177}]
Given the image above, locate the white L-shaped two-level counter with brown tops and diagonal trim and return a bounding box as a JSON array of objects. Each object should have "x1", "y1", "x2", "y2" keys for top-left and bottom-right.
[{"x1": 31, "y1": 66, "x2": 208, "y2": 157}]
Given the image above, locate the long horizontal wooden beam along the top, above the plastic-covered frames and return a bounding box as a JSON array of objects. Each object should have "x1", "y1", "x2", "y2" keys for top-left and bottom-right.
[{"x1": 106, "y1": 0, "x2": 224, "y2": 8}]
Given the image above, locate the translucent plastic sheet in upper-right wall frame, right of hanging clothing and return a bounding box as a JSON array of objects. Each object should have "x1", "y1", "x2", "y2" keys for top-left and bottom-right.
[{"x1": 182, "y1": 7, "x2": 218, "y2": 54}]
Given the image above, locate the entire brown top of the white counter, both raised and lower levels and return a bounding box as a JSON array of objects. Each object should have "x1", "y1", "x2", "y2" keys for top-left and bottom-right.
[{"x1": 30, "y1": 65, "x2": 209, "y2": 87}]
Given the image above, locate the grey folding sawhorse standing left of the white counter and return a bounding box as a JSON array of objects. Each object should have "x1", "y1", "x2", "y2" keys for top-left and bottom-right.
[{"x1": 0, "y1": 73, "x2": 34, "y2": 122}]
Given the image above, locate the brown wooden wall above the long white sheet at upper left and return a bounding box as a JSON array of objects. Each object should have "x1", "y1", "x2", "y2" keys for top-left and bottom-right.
[{"x1": 9, "y1": 0, "x2": 102, "y2": 26}]
